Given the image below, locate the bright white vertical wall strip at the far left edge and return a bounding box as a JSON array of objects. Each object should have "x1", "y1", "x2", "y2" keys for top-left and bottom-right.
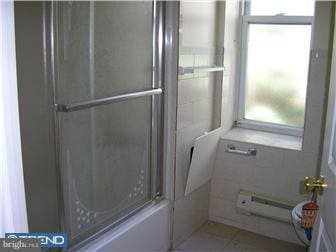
[{"x1": 0, "y1": 1, "x2": 28, "y2": 237}]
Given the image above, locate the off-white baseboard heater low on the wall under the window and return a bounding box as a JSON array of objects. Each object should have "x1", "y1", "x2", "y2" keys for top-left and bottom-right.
[{"x1": 237, "y1": 190, "x2": 296, "y2": 223}]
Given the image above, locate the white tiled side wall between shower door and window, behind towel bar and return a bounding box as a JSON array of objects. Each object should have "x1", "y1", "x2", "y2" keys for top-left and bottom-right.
[{"x1": 173, "y1": 1, "x2": 221, "y2": 247}]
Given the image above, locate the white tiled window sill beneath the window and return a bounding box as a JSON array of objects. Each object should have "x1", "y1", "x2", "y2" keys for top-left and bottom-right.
[{"x1": 221, "y1": 128, "x2": 302, "y2": 151}]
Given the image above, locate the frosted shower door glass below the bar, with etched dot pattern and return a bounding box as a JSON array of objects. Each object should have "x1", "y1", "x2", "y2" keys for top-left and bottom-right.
[{"x1": 59, "y1": 97, "x2": 151, "y2": 240}]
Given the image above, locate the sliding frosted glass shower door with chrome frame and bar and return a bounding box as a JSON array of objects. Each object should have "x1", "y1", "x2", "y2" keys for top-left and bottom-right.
[{"x1": 52, "y1": 1, "x2": 163, "y2": 246}]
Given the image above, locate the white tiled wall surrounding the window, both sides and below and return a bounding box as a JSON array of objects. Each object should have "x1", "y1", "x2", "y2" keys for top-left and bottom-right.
[{"x1": 210, "y1": 1, "x2": 331, "y2": 243}]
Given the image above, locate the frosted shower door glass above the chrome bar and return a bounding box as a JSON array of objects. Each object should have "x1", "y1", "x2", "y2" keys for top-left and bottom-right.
[{"x1": 57, "y1": 1, "x2": 153, "y2": 103}]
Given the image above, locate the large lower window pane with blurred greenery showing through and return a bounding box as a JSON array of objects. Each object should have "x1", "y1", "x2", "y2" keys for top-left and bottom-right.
[{"x1": 245, "y1": 24, "x2": 311, "y2": 126}]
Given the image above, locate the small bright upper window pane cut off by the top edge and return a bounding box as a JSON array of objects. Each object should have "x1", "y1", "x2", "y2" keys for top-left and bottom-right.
[{"x1": 249, "y1": 0, "x2": 314, "y2": 16}]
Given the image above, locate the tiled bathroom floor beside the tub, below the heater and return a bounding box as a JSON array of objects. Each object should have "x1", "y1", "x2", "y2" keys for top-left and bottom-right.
[{"x1": 173, "y1": 221, "x2": 306, "y2": 252}]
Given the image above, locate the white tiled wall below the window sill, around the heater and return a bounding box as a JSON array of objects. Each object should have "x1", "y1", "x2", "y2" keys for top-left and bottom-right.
[{"x1": 210, "y1": 139, "x2": 318, "y2": 243}]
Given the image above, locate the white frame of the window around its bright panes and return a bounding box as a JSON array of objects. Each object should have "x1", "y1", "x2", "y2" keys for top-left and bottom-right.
[{"x1": 236, "y1": 1, "x2": 314, "y2": 137}]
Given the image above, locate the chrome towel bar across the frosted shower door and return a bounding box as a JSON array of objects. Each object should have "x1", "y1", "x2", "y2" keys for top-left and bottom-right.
[{"x1": 55, "y1": 88, "x2": 162, "y2": 112}]
